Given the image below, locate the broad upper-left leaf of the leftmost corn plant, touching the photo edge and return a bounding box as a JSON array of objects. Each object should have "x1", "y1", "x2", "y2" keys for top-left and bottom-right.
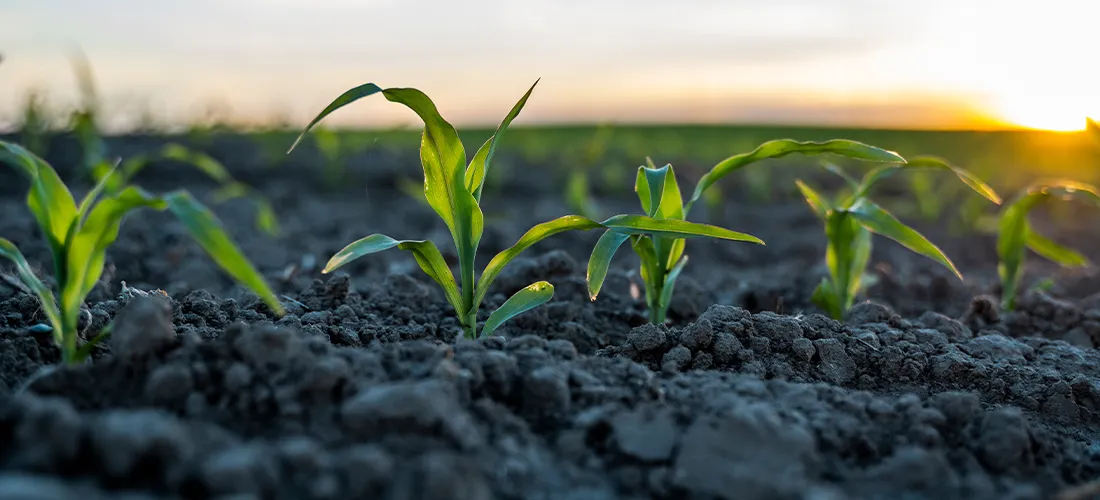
[{"x1": 0, "y1": 141, "x2": 77, "y2": 260}]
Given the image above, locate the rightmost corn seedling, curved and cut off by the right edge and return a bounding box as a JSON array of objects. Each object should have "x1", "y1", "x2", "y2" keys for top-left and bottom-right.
[{"x1": 997, "y1": 180, "x2": 1100, "y2": 310}]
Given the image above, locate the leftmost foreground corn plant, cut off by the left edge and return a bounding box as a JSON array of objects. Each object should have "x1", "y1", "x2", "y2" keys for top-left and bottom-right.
[{"x1": 0, "y1": 141, "x2": 283, "y2": 365}]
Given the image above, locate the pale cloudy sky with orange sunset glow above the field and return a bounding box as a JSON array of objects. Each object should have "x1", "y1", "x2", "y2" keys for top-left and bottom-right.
[{"x1": 0, "y1": 0, "x2": 1100, "y2": 130}]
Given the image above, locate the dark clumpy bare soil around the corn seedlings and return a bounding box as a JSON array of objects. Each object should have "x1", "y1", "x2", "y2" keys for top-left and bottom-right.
[{"x1": 0, "y1": 136, "x2": 1100, "y2": 500}]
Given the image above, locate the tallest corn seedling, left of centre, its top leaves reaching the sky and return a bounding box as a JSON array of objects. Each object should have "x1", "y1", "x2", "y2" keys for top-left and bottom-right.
[{"x1": 290, "y1": 82, "x2": 748, "y2": 338}]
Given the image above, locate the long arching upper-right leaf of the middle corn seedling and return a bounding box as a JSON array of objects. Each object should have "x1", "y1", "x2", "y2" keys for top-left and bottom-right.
[{"x1": 684, "y1": 138, "x2": 905, "y2": 213}]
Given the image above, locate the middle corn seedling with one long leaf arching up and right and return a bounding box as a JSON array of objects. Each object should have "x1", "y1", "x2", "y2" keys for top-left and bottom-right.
[{"x1": 587, "y1": 140, "x2": 904, "y2": 324}]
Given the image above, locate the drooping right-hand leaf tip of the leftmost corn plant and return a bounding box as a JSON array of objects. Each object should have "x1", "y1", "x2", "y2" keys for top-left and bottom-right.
[{"x1": 164, "y1": 191, "x2": 285, "y2": 315}]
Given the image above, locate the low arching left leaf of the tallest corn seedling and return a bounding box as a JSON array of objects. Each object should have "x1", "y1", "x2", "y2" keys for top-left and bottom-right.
[{"x1": 321, "y1": 234, "x2": 465, "y2": 314}]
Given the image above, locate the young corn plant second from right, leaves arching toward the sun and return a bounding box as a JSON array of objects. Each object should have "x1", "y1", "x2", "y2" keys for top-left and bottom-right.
[{"x1": 796, "y1": 156, "x2": 1001, "y2": 320}]
